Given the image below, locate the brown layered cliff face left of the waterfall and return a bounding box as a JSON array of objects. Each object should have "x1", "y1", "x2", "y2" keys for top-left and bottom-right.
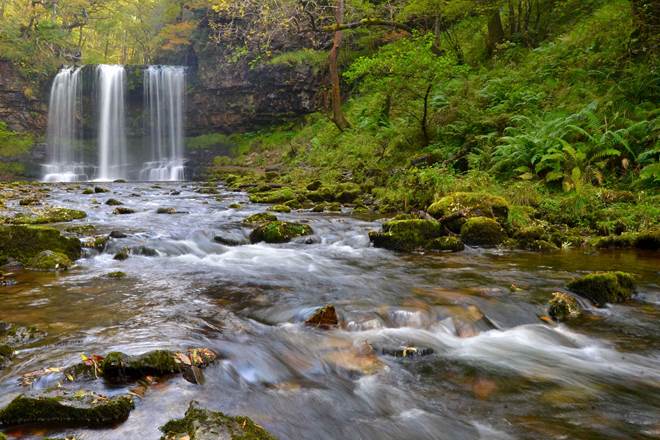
[{"x1": 0, "y1": 59, "x2": 48, "y2": 133}]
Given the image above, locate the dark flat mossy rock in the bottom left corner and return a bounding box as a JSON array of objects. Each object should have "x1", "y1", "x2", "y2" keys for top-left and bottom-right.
[{"x1": 0, "y1": 390, "x2": 134, "y2": 428}]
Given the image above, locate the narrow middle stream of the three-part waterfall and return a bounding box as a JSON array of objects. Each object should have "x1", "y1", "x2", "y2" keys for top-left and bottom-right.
[{"x1": 96, "y1": 64, "x2": 128, "y2": 180}]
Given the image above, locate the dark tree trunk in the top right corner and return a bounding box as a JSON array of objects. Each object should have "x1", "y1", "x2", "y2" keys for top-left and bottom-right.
[{"x1": 631, "y1": 0, "x2": 660, "y2": 54}]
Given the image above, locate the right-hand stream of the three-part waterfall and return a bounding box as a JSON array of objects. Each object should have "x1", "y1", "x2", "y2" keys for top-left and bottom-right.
[{"x1": 140, "y1": 66, "x2": 186, "y2": 181}]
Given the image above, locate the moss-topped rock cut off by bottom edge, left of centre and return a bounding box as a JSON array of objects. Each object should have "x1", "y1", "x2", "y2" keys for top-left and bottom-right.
[{"x1": 160, "y1": 404, "x2": 275, "y2": 440}]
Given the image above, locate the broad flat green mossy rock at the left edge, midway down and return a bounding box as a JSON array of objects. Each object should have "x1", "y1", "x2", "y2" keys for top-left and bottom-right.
[{"x1": 0, "y1": 226, "x2": 81, "y2": 263}]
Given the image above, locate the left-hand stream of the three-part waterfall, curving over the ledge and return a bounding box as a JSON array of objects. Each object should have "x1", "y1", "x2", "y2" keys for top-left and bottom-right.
[{"x1": 44, "y1": 67, "x2": 87, "y2": 182}]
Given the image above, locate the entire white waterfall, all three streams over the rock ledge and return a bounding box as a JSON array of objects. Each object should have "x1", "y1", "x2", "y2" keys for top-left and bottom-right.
[{"x1": 42, "y1": 64, "x2": 186, "y2": 182}]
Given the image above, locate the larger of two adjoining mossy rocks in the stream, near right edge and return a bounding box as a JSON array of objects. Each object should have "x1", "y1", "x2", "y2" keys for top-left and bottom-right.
[{"x1": 568, "y1": 272, "x2": 635, "y2": 307}]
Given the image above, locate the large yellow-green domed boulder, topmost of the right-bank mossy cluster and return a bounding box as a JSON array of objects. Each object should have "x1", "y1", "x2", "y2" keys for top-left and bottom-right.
[{"x1": 427, "y1": 192, "x2": 509, "y2": 232}]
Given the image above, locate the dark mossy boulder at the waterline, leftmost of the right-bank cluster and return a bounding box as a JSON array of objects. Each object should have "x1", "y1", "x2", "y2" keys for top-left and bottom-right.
[{"x1": 369, "y1": 219, "x2": 443, "y2": 251}]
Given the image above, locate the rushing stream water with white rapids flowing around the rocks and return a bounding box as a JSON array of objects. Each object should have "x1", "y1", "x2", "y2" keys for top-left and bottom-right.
[{"x1": 0, "y1": 184, "x2": 660, "y2": 440}]
